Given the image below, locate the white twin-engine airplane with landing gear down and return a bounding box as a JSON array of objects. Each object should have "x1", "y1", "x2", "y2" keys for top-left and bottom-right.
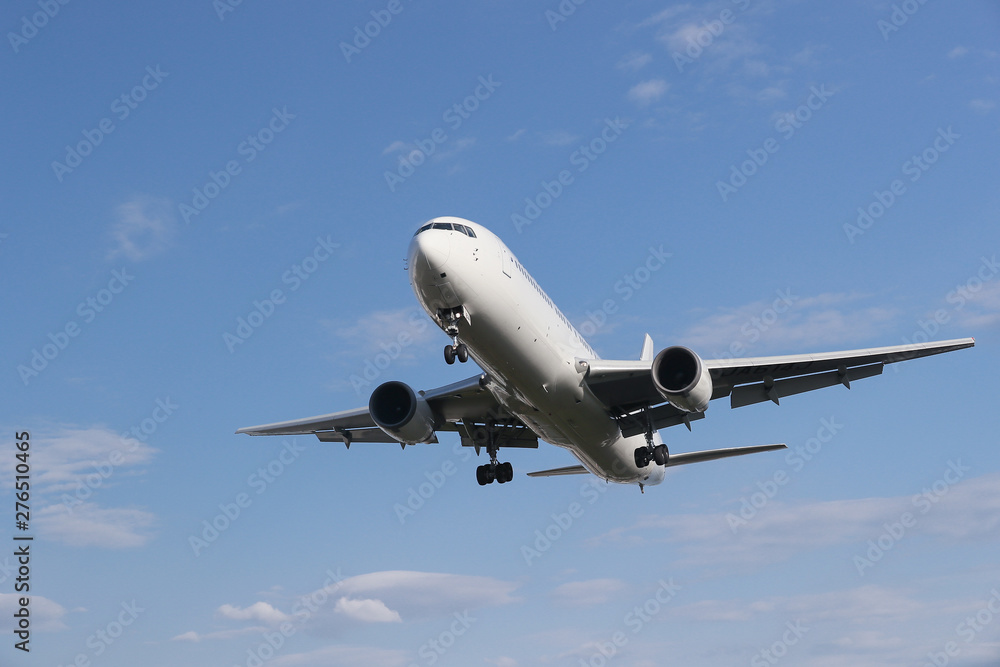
[{"x1": 236, "y1": 217, "x2": 975, "y2": 489}]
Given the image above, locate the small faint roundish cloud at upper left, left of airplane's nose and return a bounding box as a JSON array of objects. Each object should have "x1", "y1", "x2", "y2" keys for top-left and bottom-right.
[{"x1": 109, "y1": 195, "x2": 177, "y2": 262}]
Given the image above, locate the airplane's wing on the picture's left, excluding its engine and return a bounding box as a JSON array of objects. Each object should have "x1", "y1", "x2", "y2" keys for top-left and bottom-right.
[{"x1": 236, "y1": 375, "x2": 538, "y2": 448}]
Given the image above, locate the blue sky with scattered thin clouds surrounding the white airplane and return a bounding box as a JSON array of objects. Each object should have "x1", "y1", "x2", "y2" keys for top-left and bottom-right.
[{"x1": 0, "y1": 0, "x2": 1000, "y2": 667}]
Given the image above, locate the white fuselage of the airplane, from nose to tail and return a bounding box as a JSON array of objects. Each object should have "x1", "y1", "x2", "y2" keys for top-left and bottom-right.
[{"x1": 408, "y1": 217, "x2": 664, "y2": 485}]
